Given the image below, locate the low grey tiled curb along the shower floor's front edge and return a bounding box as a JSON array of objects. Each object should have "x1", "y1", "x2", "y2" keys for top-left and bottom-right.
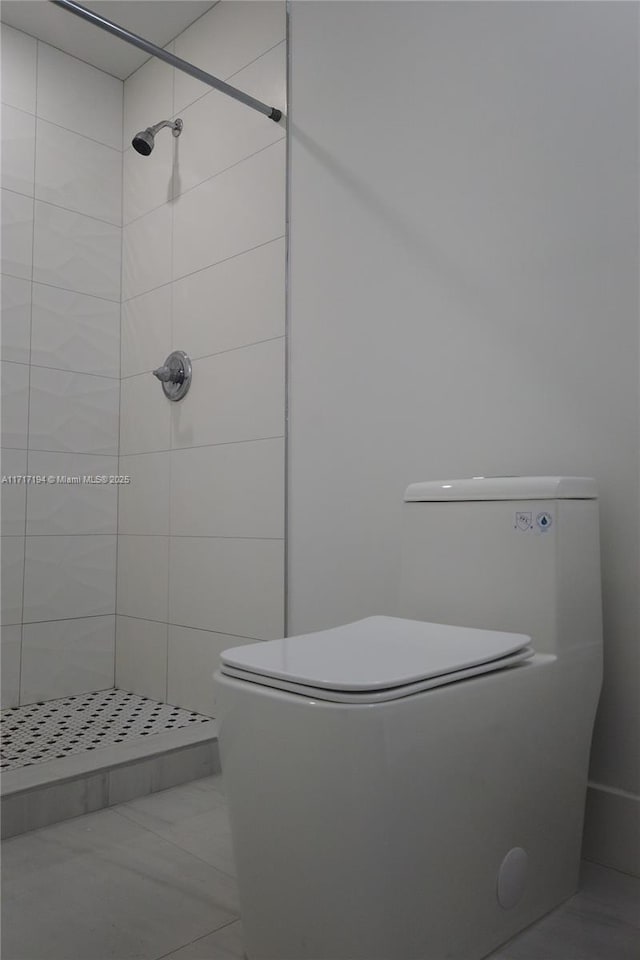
[{"x1": 0, "y1": 720, "x2": 220, "y2": 839}]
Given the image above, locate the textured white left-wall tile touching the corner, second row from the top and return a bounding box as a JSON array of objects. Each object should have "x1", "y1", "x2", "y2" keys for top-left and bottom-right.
[{"x1": 36, "y1": 119, "x2": 122, "y2": 225}]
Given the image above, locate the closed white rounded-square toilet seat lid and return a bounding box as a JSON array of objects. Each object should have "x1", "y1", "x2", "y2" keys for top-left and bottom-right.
[{"x1": 220, "y1": 617, "x2": 531, "y2": 694}]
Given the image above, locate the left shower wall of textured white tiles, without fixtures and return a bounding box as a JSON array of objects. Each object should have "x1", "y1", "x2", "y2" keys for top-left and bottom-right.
[{"x1": 2, "y1": 25, "x2": 122, "y2": 707}]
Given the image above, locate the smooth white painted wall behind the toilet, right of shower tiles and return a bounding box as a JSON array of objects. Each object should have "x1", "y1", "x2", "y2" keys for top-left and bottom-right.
[{"x1": 289, "y1": 2, "x2": 640, "y2": 870}]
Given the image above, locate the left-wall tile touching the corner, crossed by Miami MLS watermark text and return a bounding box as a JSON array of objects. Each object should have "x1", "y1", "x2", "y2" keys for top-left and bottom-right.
[{"x1": 27, "y1": 450, "x2": 118, "y2": 536}]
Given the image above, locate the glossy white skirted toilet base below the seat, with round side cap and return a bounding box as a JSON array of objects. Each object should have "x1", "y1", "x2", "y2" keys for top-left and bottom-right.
[{"x1": 218, "y1": 648, "x2": 599, "y2": 960}]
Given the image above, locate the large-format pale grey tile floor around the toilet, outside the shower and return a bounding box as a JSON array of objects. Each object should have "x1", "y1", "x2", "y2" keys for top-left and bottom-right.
[{"x1": 2, "y1": 776, "x2": 640, "y2": 960}]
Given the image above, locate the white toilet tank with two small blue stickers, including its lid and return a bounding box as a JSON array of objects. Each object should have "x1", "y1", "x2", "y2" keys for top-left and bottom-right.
[{"x1": 400, "y1": 477, "x2": 602, "y2": 655}]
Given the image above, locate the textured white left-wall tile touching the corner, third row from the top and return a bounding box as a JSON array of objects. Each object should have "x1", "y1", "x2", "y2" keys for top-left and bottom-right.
[{"x1": 33, "y1": 200, "x2": 120, "y2": 300}]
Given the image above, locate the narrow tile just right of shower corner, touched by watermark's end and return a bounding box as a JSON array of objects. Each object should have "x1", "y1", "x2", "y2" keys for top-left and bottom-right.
[{"x1": 118, "y1": 451, "x2": 171, "y2": 534}]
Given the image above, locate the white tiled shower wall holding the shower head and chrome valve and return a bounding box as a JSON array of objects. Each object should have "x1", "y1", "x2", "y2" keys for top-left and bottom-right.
[{"x1": 116, "y1": 0, "x2": 286, "y2": 714}]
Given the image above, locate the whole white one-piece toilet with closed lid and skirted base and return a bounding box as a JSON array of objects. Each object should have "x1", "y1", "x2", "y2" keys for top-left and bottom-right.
[{"x1": 216, "y1": 477, "x2": 602, "y2": 960}]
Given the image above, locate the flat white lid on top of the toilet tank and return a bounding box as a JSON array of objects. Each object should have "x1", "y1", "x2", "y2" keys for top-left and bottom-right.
[{"x1": 404, "y1": 477, "x2": 598, "y2": 503}]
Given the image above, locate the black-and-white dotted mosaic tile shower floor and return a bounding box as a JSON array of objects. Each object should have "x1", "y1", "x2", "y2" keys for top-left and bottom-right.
[{"x1": 0, "y1": 689, "x2": 211, "y2": 770}]
